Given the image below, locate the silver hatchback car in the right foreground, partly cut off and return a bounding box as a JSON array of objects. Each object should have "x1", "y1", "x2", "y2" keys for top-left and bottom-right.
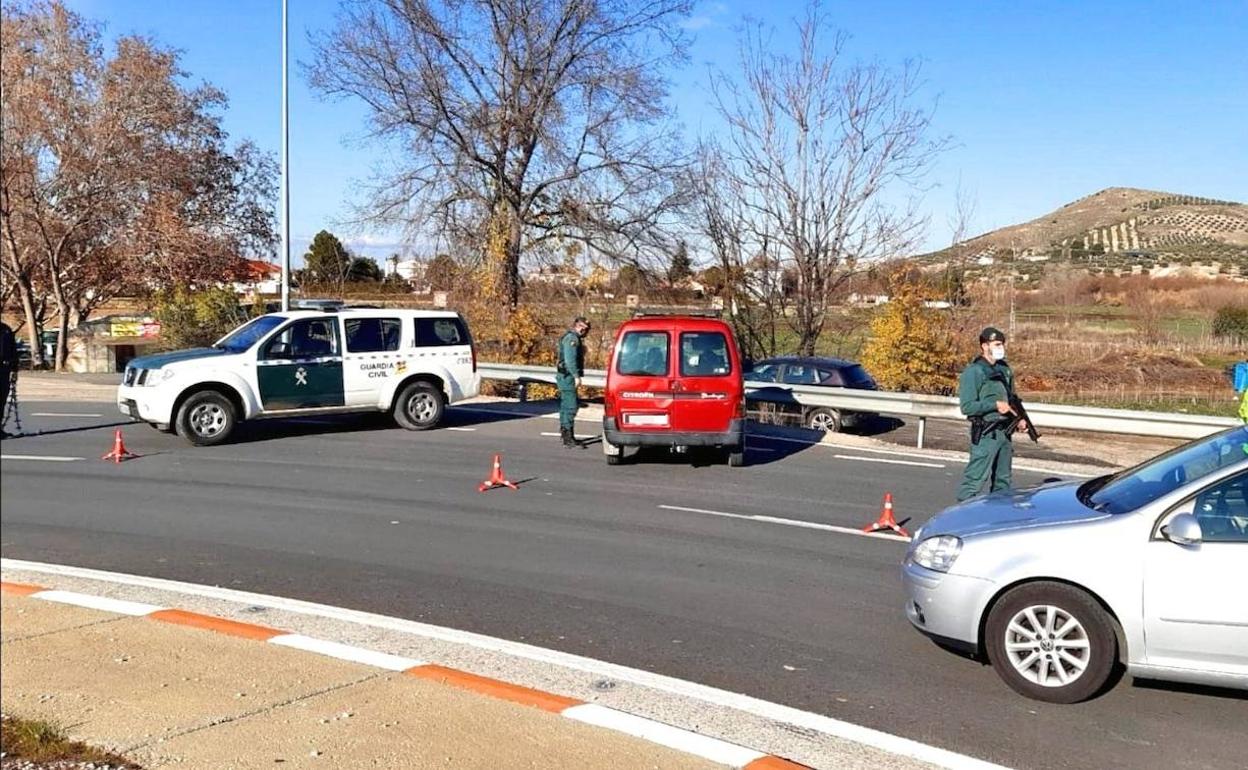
[{"x1": 902, "y1": 427, "x2": 1248, "y2": 703}]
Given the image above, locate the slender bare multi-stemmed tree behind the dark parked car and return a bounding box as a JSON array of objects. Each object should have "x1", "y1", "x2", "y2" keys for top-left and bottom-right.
[{"x1": 700, "y1": 2, "x2": 947, "y2": 354}]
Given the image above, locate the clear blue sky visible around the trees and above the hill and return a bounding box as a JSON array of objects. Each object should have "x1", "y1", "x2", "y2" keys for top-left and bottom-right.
[{"x1": 56, "y1": 0, "x2": 1248, "y2": 263}]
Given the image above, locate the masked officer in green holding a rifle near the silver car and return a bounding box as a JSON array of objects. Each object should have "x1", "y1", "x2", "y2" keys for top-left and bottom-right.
[{"x1": 957, "y1": 326, "x2": 1027, "y2": 500}]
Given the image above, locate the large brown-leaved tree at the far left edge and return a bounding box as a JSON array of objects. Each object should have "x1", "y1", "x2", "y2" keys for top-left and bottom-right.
[{"x1": 0, "y1": 2, "x2": 275, "y2": 367}]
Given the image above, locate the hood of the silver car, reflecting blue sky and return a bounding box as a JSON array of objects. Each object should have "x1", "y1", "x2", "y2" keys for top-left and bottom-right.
[{"x1": 915, "y1": 482, "x2": 1109, "y2": 543}]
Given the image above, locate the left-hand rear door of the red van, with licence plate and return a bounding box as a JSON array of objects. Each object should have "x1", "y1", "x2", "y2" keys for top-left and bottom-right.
[{"x1": 612, "y1": 329, "x2": 673, "y2": 432}]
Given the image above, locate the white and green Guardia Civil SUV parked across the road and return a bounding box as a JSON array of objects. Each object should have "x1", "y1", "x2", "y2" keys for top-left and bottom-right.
[{"x1": 117, "y1": 307, "x2": 480, "y2": 447}]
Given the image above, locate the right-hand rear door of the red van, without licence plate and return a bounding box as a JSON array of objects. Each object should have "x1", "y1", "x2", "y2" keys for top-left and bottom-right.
[{"x1": 673, "y1": 328, "x2": 741, "y2": 433}]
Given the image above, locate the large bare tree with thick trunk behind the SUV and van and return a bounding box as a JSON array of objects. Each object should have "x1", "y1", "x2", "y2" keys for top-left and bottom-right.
[{"x1": 308, "y1": 0, "x2": 691, "y2": 308}]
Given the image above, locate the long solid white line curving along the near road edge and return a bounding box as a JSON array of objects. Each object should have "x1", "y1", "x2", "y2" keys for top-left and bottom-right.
[{"x1": 0, "y1": 558, "x2": 1005, "y2": 770}]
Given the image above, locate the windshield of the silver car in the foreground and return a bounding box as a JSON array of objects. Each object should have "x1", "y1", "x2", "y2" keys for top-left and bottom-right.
[{"x1": 1080, "y1": 426, "x2": 1248, "y2": 514}]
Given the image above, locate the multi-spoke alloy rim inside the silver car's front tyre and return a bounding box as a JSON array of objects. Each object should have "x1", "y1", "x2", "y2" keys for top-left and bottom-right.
[{"x1": 1005, "y1": 604, "x2": 1092, "y2": 688}]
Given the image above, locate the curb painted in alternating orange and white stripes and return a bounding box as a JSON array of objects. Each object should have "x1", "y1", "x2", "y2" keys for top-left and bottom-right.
[{"x1": 0, "y1": 580, "x2": 809, "y2": 770}]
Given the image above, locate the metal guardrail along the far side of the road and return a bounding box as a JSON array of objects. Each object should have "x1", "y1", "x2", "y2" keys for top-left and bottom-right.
[{"x1": 478, "y1": 363, "x2": 1241, "y2": 448}]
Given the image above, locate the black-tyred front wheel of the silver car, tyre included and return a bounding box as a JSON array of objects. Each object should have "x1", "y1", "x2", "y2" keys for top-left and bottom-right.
[{"x1": 985, "y1": 583, "x2": 1118, "y2": 703}]
